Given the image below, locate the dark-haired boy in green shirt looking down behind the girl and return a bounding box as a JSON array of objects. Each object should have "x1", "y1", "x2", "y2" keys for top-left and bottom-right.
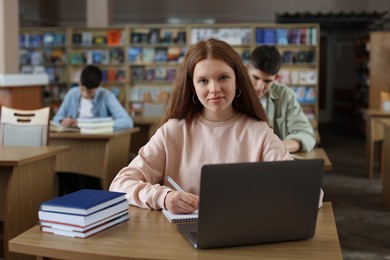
[{"x1": 248, "y1": 45, "x2": 316, "y2": 153}]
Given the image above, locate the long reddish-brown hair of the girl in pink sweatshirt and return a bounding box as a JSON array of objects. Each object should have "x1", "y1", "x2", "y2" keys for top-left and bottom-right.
[{"x1": 160, "y1": 39, "x2": 267, "y2": 125}]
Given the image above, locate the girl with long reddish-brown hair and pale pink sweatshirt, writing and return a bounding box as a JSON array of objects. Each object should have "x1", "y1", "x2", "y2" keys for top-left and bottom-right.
[{"x1": 110, "y1": 39, "x2": 320, "y2": 214}]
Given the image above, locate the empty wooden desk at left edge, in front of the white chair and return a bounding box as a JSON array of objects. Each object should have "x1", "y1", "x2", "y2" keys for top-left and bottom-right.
[{"x1": 0, "y1": 146, "x2": 70, "y2": 259}]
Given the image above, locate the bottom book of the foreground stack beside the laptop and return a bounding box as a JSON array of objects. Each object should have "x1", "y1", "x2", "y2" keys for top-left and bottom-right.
[{"x1": 40, "y1": 212, "x2": 129, "y2": 238}]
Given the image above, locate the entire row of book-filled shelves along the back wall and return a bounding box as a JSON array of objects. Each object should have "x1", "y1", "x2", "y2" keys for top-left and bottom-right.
[{"x1": 20, "y1": 24, "x2": 319, "y2": 121}]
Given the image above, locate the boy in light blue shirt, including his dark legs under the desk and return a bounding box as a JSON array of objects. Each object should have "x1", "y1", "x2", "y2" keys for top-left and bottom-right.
[{"x1": 53, "y1": 65, "x2": 134, "y2": 196}]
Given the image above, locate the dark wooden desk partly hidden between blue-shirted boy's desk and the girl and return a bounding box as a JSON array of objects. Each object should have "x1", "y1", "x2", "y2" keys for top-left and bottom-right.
[{"x1": 130, "y1": 116, "x2": 160, "y2": 155}]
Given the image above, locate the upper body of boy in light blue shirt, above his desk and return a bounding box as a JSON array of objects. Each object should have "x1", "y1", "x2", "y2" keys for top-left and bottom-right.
[{"x1": 53, "y1": 65, "x2": 134, "y2": 130}]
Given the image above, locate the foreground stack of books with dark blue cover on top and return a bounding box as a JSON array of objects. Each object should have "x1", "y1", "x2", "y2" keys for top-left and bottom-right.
[{"x1": 38, "y1": 189, "x2": 129, "y2": 238}]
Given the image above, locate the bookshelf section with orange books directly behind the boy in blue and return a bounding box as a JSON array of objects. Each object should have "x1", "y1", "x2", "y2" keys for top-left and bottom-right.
[{"x1": 68, "y1": 27, "x2": 129, "y2": 105}]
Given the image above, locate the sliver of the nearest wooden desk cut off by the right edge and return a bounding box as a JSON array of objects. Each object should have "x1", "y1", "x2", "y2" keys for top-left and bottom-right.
[{"x1": 380, "y1": 119, "x2": 390, "y2": 206}]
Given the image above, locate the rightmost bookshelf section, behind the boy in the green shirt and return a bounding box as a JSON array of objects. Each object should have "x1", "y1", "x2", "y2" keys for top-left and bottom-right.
[{"x1": 253, "y1": 24, "x2": 320, "y2": 122}]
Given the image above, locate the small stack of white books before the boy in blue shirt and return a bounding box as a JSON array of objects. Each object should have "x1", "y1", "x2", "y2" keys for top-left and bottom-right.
[{"x1": 77, "y1": 117, "x2": 114, "y2": 134}]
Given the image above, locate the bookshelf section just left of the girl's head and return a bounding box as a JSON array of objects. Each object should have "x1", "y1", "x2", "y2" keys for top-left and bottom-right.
[{"x1": 127, "y1": 24, "x2": 187, "y2": 116}]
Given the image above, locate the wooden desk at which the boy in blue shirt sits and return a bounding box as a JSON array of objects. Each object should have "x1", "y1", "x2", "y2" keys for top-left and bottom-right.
[{"x1": 49, "y1": 127, "x2": 139, "y2": 190}]
